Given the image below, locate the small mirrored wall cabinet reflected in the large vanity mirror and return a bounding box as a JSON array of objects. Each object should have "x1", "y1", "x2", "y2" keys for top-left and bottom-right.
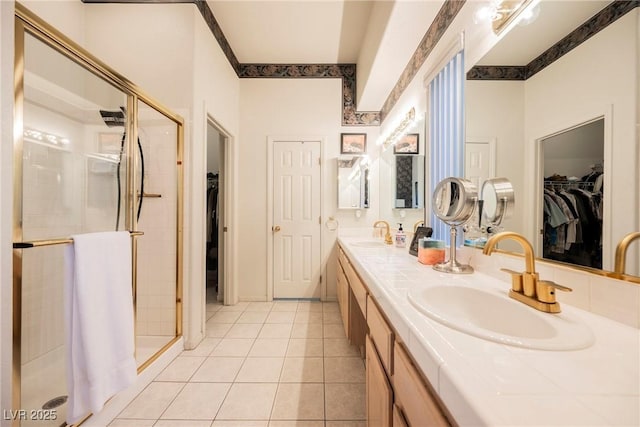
[{"x1": 394, "y1": 154, "x2": 425, "y2": 209}]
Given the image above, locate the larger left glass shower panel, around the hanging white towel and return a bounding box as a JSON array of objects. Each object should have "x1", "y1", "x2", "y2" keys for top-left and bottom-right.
[{"x1": 14, "y1": 33, "x2": 128, "y2": 426}]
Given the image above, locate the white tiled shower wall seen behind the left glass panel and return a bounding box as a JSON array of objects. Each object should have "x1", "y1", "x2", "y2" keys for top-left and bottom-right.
[{"x1": 22, "y1": 103, "x2": 116, "y2": 363}]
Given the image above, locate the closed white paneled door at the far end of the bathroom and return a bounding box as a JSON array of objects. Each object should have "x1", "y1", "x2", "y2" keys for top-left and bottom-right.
[{"x1": 272, "y1": 141, "x2": 321, "y2": 298}]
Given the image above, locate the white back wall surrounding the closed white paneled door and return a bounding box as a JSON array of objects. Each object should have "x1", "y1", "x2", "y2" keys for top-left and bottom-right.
[{"x1": 236, "y1": 79, "x2": 379, "y2": 300}]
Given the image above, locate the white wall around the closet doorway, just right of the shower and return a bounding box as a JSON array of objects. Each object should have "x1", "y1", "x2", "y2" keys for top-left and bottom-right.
[{"x1": 190, "y1": 7, "x2": 240, "y2": 346}]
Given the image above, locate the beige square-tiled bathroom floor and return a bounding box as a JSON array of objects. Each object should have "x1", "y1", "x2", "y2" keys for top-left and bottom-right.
[{"x1": 110, "y1": 301, "x2": 366, "y2": 427}]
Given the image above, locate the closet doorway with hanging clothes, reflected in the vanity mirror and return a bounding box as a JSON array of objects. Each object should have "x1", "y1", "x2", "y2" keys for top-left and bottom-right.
[{"x1": 540, "y1": 117, "x2": 606, "y2": 269}]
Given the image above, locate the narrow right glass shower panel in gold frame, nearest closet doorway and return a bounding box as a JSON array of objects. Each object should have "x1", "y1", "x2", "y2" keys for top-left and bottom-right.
[{"x1": 135, "y1": 101, "x2": 179, "y2": 366}]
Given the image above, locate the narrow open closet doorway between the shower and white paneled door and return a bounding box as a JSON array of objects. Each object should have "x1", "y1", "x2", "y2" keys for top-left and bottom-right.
[{"x1": 205, "y1": 120, "x2": 227, "y2": 303}]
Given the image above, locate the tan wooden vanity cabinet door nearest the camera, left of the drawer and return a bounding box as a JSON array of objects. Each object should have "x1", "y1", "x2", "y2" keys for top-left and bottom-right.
[{"x1": 366, "y1": 335, "x2": 393, "y2": 427}]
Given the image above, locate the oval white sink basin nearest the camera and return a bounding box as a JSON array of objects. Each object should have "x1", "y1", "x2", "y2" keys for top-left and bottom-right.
[{"x1": 408, "y1": 284, "x2": 594, "y2": 350}]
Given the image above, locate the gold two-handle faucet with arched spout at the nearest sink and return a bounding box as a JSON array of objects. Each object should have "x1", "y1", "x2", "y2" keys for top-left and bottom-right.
[{"x1": 482, "y1": 231, "x2": 571, "y2": 313}]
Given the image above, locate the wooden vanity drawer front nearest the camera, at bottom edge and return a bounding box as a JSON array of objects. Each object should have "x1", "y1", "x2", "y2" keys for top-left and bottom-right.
[{"x1": 393, "y1": 342, "x2": 451, "y2": 427}]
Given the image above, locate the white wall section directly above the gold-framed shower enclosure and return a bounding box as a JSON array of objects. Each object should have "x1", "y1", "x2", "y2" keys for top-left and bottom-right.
[{"x1": 85, "y1": 4, "x2": 195, "y2": 113}]
